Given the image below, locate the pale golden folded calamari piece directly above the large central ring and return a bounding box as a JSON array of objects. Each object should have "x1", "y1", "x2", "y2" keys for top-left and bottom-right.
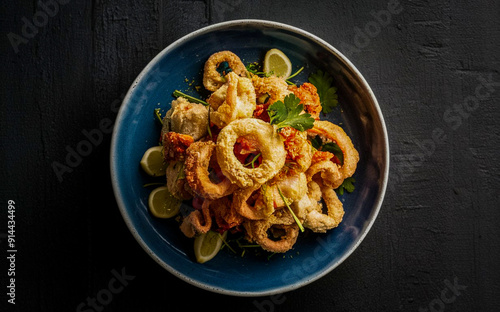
[{"x1": 210, "y1": 72, "x2": 256, "y2": 128}]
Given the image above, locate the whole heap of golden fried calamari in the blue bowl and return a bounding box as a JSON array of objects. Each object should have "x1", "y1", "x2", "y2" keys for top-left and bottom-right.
[{"x1": 161, "y1": 51, "x2": 359, "y2": 253}]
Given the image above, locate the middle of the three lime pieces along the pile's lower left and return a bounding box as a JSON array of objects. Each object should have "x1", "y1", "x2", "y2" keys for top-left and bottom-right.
[{"x1": 148, "y1": 186, "x2": 182, "y2": 219}]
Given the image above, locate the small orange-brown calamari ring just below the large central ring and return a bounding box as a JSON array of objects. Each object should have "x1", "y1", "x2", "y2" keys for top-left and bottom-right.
[{"x1": 231, "y1": 185, "x2": 274, "y2": 220}]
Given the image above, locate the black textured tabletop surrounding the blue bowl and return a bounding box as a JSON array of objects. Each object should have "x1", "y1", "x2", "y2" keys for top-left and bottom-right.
[{"x1": 0, "y1": 0, "x2": 500, "y2": 311}]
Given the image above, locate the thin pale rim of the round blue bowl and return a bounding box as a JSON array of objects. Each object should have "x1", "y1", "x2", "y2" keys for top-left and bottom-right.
[{"x1": 110, "y1": 19, "x2": 390, "y2": 297}]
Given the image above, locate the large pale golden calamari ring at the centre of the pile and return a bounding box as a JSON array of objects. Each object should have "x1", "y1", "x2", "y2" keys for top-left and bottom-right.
[{"x1": 216, "y1": 118, "x2": 286, "y2": 188}]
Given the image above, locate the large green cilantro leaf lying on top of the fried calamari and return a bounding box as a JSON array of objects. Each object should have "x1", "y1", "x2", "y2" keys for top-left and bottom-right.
[{"x1": 267, "y1": 93, "x2": 314, "y2": 131}]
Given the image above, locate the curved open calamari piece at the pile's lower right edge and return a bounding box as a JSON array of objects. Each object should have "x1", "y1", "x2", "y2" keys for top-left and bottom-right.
[{"x1": 302, "y1": 182, "x2": 344, "y2": 233}]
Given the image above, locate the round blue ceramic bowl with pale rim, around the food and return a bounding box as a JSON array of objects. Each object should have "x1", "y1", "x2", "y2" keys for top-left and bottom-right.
[{"x1": 111, "y1": 20, "x2": 389, "y2": 296}]
